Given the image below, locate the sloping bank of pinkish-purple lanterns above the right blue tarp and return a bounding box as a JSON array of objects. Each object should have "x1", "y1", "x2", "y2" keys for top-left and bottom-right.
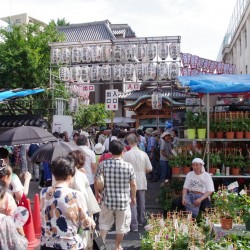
[{"x1": 180, "y1": 53, "x2": 236, "y2": 75}]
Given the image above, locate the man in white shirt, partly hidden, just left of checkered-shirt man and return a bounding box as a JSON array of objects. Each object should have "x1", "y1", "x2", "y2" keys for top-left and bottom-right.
[{"x1": 77, "y1": 135, "x2": 96, "y2": 192}]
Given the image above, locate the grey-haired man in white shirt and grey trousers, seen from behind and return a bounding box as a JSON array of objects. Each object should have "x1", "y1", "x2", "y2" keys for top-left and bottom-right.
[{"x1": 123, "y1": 134, "x2": 152, "y2": 232}]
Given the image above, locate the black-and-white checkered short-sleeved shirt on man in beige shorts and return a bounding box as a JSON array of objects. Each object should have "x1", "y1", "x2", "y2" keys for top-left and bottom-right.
[{"x1": 96, "y1": 158, "x2": 135, "y2": 210}]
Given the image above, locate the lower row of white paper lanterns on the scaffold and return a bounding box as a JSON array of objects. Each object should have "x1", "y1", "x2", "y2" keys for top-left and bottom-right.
[{"x1": 59, "y1": 62, "x2": 179, "y2": 82}]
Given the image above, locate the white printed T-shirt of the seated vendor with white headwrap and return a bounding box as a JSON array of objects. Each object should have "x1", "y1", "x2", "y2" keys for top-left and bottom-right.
[{"x1": 183, "y1": 171, "x2": 214, "y2": 193}]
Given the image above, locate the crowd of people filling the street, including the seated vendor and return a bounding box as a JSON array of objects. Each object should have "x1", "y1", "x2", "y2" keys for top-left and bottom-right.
[{"x1": 0, "y1": 127, "x2": 214, "y2": 250}]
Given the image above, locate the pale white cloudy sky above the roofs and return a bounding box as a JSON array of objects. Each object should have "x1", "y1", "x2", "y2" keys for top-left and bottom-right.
[{"x1": 0, "y1": 0, "x2": 236, "y2": 60}]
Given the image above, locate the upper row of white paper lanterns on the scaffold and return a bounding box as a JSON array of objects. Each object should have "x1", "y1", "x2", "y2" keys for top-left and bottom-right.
[{"x1": 51, "y1": 42, "x2": 180, "y2": 64}]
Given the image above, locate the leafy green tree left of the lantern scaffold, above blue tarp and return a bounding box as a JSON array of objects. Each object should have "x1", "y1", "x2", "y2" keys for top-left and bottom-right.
[{"x1": 0, "y1": 22, "x2": 63, "y2": 89}]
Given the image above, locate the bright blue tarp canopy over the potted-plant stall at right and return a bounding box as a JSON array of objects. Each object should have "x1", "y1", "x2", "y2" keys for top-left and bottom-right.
[{"x1": 177, "y1": 74, "x2": 250, "y2": 94}]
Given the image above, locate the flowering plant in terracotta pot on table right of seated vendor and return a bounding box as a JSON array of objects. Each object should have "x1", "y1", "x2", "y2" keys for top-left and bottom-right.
[{"x1": 212, "y1": 190, "x2": 240, "y2": 229}]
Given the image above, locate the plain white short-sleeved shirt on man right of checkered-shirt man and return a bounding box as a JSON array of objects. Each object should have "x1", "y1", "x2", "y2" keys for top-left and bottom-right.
[{"x1": 123, "y1": 147, "x2": 152, "y2": 190}]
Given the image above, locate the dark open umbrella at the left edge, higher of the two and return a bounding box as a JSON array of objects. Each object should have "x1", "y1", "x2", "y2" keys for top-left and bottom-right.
[{"x1": 0, "y1": 126, "x2": 57, "y2": 146}]
